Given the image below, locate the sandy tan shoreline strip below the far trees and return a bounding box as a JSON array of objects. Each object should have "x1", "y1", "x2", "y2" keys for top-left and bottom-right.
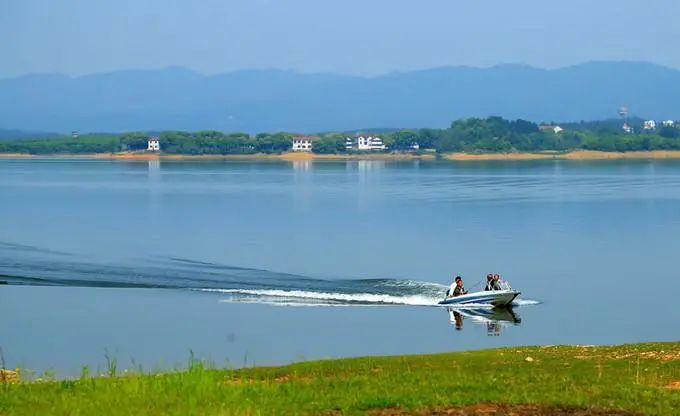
[{"x1": 0, "y1": 150, "x2": 680, "y2": 162}]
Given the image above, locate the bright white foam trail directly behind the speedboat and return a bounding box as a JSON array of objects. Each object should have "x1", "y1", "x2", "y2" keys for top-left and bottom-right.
[{"x1": 196, "y1": 289, "x2": 440, "y2": 306}]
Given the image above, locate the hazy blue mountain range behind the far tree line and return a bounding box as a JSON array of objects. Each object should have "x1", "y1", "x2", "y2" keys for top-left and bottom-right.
[{"x1": 0, "y1": 62, "x2": 680, "y2": 132}]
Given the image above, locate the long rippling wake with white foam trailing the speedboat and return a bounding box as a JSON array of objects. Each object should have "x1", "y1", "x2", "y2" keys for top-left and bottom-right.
[{"x1": 0, "y1": 242, "x2": 537, "y2": 307}]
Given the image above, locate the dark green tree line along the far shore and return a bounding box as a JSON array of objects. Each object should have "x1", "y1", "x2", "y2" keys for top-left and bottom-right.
[{"x1": 0, "y1": 117, "x2": 680, "y2": 155}]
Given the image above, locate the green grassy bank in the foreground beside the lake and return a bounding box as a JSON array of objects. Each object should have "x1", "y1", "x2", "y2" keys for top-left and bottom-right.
[{"x1": 0, "y1": 342, "x2": 680, "y2": 416}]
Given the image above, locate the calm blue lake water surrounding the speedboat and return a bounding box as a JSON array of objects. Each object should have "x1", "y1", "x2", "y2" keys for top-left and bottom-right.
[{"x1": 0, "y1": 158, "x2": 680, "y2": 376}]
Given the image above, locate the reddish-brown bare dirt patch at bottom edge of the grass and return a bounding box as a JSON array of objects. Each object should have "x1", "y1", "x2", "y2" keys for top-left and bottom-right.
[{"x1": 367, "y1": 403, "x2": 641, "y2": 416}]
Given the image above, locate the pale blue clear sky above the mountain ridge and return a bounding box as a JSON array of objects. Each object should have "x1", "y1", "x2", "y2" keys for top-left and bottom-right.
[{"x1": 0, "y1": 0, "x2": 680, "y2": 77}]
